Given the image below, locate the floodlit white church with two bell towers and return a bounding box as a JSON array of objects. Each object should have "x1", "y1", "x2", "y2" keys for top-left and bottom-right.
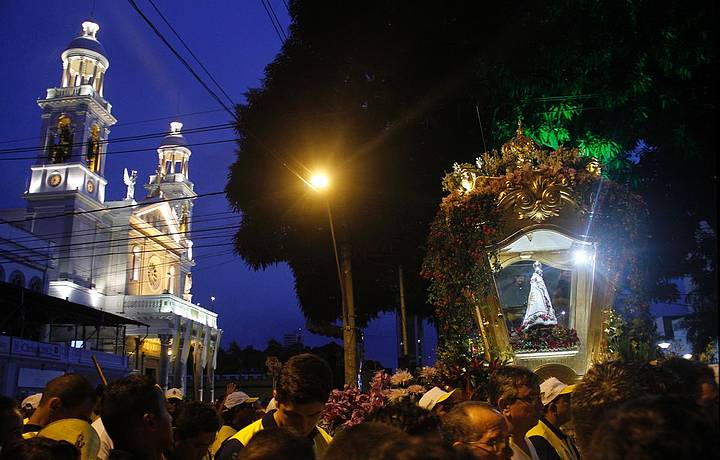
[{"x1": 1, "y1": 21, "x2": 222, "y2": 400}]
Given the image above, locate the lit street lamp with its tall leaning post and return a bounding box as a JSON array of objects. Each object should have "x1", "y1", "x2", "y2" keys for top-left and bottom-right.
[{"x1": 309, "y1": 173, "x2": 357, "y2": 385}]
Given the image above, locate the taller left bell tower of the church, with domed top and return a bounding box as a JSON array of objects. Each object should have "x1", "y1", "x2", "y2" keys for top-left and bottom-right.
[{"x1": 27, "y1": 21, "x2": 117, "y2": 203}]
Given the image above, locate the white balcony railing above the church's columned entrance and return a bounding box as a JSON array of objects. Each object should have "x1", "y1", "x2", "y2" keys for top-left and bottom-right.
[{"x1": 123, "y1": 294, "x2": 217, "y2": 328}]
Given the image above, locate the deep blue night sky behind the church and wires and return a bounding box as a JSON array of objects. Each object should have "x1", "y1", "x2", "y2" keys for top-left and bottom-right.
[{"x1": 0, "y1": 0, "x2": 434, "y2": 366}]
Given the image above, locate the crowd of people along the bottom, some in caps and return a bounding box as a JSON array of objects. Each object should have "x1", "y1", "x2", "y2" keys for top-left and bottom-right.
[{"x1": 0, "y1": 354, "x2": 720, "y2": 460}]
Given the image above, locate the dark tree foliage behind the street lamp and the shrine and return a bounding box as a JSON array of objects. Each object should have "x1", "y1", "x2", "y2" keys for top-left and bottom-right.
[{"x1": 227, "y1": 0, "x2": 717, "y2": 348}]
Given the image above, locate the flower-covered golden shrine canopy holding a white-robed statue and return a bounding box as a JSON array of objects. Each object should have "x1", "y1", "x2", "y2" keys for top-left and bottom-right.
[{"x1": 422, "y1": 126, "x2": 646, "y2": 375}]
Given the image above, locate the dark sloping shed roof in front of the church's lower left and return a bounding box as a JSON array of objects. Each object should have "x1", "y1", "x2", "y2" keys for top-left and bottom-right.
[{"x1": 0, "y1": 282, "x2": 148, "y2": 327}]
